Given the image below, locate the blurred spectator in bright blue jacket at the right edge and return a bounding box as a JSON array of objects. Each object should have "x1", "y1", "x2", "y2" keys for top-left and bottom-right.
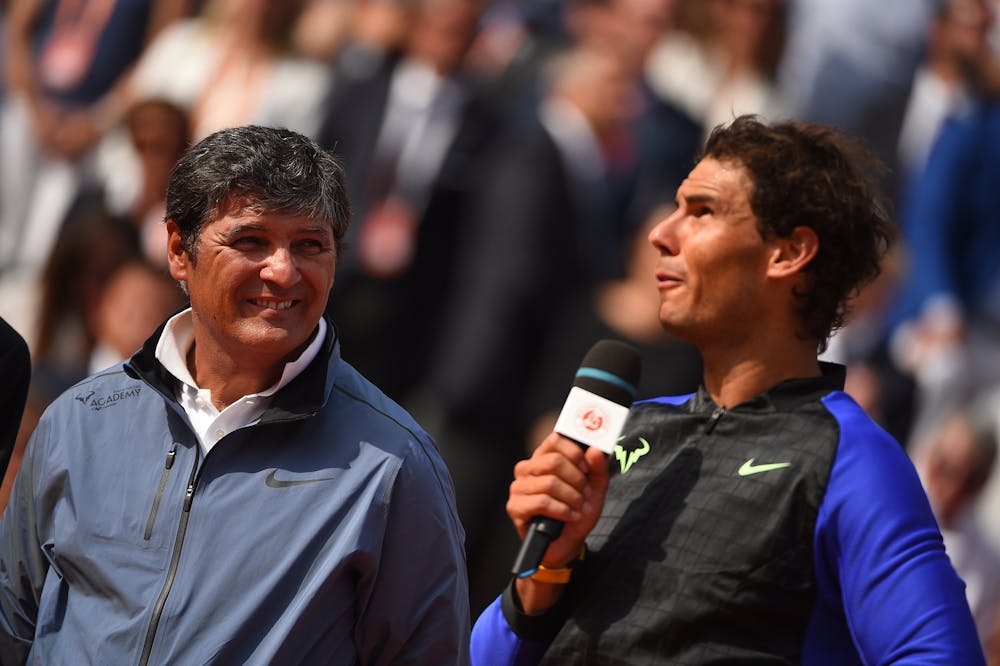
[{"x1": 892, "y1": 91, "x2": 1000, "y2": 446}]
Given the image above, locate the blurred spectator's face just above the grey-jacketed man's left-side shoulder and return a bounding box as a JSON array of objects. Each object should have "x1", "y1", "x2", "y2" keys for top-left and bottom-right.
[{"x1": 88, "y1": 259, "x2": 187, "y2": 373}]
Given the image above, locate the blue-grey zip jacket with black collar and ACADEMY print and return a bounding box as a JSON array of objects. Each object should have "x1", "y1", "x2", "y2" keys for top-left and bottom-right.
[{"x1": 0, "y1": 326, "x2": 469, "y2": 665}]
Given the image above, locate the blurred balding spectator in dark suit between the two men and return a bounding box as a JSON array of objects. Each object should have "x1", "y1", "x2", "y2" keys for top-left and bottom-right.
[{"x1": 416, "y1": 40, "x2": 638, "y2": 612}]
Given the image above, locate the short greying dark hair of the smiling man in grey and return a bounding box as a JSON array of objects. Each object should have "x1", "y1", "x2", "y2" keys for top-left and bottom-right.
[{"x1": 165, "y1": 125, "x2": 351, "y2": 262}]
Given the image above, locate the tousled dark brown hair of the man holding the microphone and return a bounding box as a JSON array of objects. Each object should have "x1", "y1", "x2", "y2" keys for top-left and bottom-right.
[{"x1": 702, "y1": 115, "x2": 896, "y2": 348}]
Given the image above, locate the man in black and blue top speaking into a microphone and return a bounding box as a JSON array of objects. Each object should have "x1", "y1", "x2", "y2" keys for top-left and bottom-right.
[{"x1": 472, "y1": 116, "x2": 984, "y2": 666}]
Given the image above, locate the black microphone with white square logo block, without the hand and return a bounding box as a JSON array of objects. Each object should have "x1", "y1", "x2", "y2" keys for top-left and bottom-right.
[{"x1": 511, "y1": 340, "x2": 640, "y2": 578}]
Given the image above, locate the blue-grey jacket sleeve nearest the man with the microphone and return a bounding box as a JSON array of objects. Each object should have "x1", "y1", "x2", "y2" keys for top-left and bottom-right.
[{"x1": 355, "y1": 438, "x2": 470, "y2": 666}]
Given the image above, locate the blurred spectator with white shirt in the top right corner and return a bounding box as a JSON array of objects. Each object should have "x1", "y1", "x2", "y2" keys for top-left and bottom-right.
[{"x1": 897, "y1": 0, "x2": 1000, "y2": 189}]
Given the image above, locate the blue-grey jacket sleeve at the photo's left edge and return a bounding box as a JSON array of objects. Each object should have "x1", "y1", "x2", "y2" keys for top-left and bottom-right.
[{"x1": 0, "y1": 418, "x2": 49, "y2": 666}]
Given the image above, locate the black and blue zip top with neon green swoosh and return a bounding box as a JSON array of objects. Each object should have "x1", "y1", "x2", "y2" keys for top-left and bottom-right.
[{"x1": 473, "y1": 372, "x2": 983, "y2": 664}]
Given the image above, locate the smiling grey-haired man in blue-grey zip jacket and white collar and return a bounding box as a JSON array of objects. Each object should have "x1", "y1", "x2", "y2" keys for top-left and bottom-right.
[{"x1": 0, "y1": 127, "x2": 469, "y2": 666}]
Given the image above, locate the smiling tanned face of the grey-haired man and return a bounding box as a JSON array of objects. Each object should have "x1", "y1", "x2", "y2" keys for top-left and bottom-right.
[{"x1": 167, "y1": 206, "x2": 336, "y2": 366}]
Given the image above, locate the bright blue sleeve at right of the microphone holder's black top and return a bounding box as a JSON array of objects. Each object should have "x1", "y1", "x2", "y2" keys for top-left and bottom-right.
[{"x1": 805, "y1": 392, "x2": 985, "y2": 666}]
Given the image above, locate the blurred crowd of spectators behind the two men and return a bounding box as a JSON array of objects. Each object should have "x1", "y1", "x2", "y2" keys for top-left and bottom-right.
[{"x1": 0, "y1": 0, "x2": 1000, "y2": 642}]
